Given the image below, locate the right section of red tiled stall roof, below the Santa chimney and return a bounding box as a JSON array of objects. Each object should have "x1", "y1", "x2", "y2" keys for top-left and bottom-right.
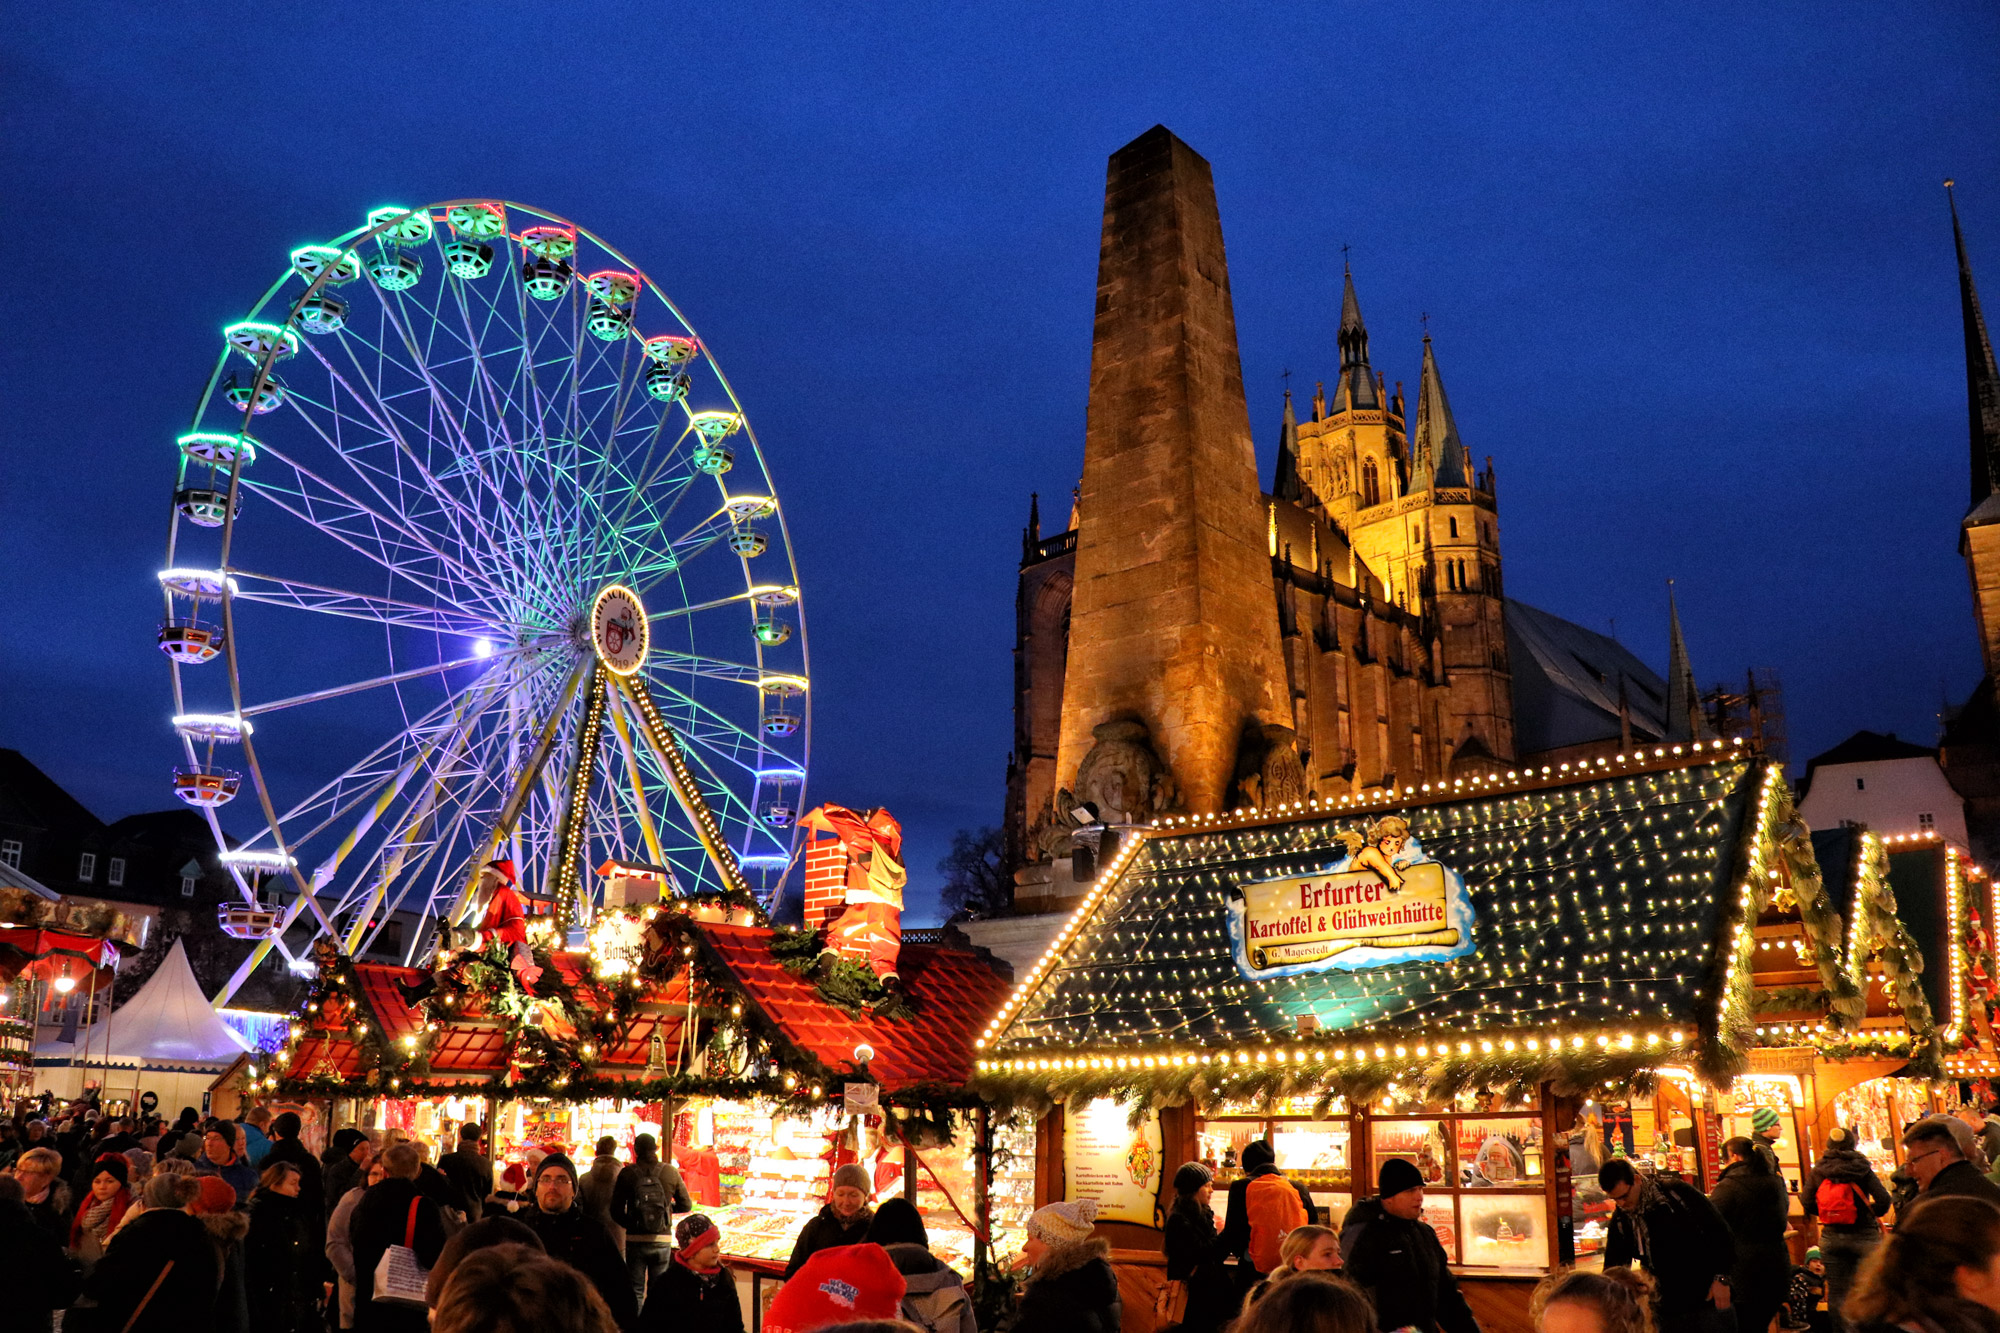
[{"x1": 698, "y1": 925, "x2": 1010, "y2": 1091}]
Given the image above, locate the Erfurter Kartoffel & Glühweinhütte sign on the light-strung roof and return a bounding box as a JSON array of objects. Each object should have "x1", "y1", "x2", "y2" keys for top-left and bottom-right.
[{"x1": 1228, "y1": 817, "x2": 1472, "y2": 981}]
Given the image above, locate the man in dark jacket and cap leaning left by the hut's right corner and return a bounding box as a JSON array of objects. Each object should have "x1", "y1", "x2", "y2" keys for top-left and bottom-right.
[{"x1": 1598, "y1": 1157, "x2": 1736, "y2": 1329}]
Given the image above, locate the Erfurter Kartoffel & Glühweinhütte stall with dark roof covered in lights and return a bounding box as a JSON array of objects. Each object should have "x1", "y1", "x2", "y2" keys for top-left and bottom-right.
[{"x1": 978, "y1": 743, "x2": 1950, "y2": 1312}]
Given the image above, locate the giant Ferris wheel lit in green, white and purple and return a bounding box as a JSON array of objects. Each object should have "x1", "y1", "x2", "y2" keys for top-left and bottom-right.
[{"x1": 158, "y1": 200, "x2": 812, "y2": 991}]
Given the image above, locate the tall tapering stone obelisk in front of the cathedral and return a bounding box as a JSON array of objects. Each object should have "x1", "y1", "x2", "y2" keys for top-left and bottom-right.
[{"x1": 1056, "y1": 126, "x2": 1292, "y2": 813}]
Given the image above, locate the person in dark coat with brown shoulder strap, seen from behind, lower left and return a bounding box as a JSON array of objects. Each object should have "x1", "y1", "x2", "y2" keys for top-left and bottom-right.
[{"x1": 62, "y1": 1175, "x2": 222, "y2": 1333}]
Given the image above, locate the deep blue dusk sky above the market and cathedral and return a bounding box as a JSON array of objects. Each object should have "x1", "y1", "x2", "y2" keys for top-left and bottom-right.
[{"x1": 0, "y1": 2, "x2": 2000, "y2": 917}]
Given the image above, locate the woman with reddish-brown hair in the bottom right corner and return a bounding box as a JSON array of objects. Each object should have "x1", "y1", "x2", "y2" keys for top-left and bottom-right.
[{"x1": 1842, "y1": 1195, "x2": 2000, "y2": 1333}]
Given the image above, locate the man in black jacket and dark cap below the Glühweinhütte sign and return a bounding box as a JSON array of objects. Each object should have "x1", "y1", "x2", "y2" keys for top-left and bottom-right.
[{"x1": 1340, "y1": 1157, "x2": 1480, "y2": 1333}]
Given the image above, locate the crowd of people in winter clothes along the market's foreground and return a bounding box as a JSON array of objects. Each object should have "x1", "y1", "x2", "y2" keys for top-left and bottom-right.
[{"x1": 11, "y1": 1088, "x2": 2000, "y2": 1333}]
